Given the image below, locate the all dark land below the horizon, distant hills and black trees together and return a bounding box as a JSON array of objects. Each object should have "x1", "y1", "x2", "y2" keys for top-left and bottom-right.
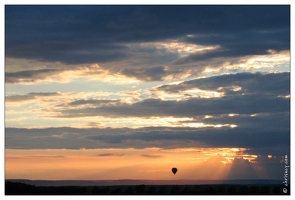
[{"x1": 5, "y1": 180, "x2": 290, "y2": 195}]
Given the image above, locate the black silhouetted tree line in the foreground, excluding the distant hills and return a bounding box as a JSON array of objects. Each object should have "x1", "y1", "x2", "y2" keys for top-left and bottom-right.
[{"x1": 5, "y1": 181, "x2": 290, "y2": 195}]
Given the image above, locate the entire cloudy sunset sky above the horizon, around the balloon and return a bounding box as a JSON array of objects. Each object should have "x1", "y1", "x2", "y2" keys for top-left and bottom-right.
[{"x1": 5, "y1": 4, "x2": 291, "y2": 181}]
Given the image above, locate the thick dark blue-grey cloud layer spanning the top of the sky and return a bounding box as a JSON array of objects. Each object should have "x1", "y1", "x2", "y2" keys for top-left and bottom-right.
[{"x1": 5, "y1": 5, "x2": 290, "y2": 83}]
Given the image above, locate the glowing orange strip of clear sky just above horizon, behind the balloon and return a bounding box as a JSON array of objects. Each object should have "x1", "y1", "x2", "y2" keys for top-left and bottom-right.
[{"x1": 5, "y1": 148, "x2": 264, "y2": 180}]
